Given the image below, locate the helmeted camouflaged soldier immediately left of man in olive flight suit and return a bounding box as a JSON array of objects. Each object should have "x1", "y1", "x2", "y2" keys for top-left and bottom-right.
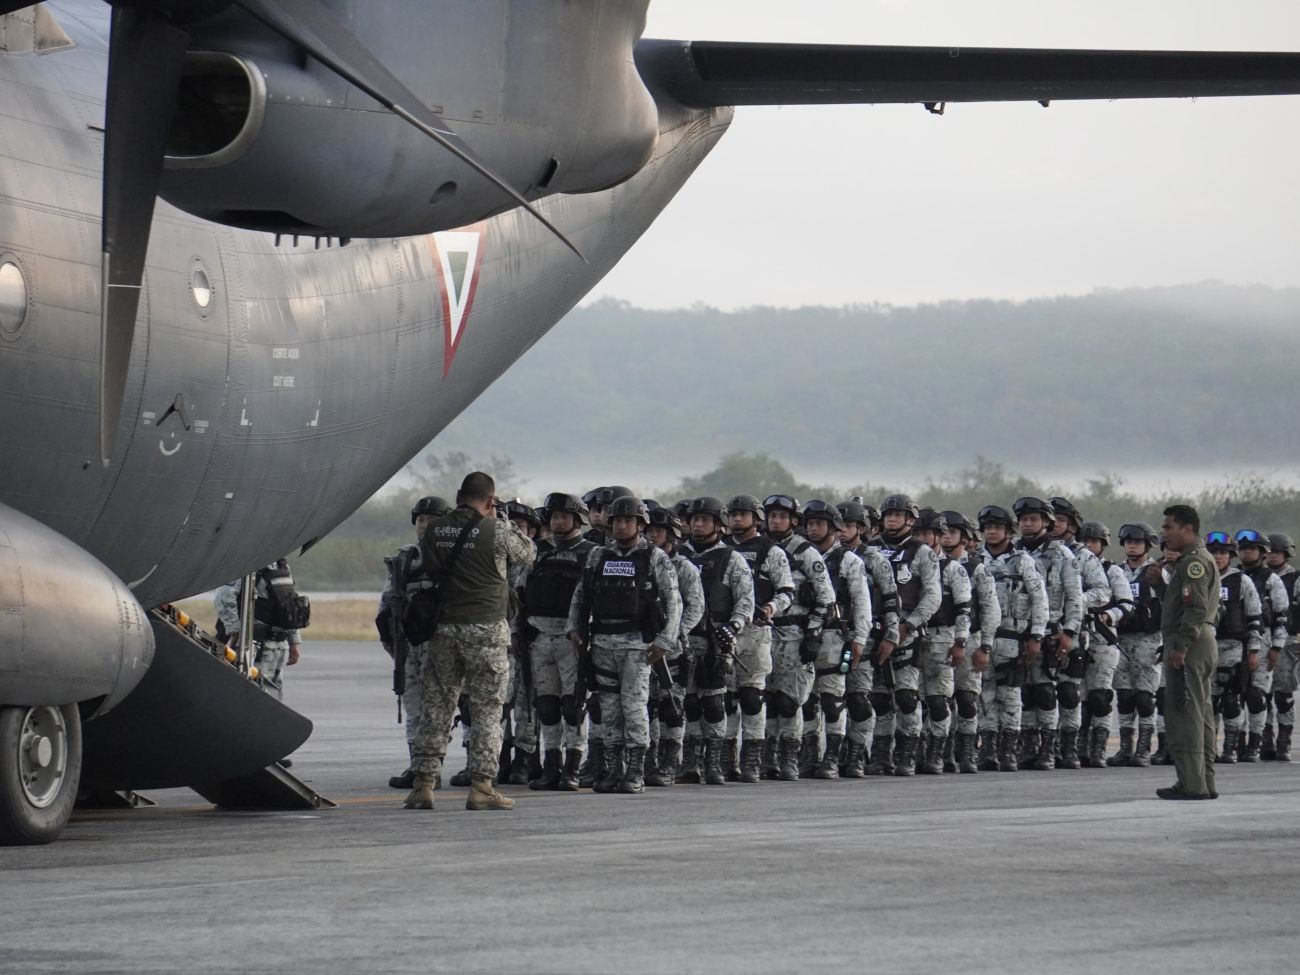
[{"x1": 1106, "y1": 521, "x2": 1165, "y2": 768}]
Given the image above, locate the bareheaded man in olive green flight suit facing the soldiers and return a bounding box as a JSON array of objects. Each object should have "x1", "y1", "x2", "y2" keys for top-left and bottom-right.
[{"x1": 1156, "y1": 504, "x2": 1219, "y2": 800}]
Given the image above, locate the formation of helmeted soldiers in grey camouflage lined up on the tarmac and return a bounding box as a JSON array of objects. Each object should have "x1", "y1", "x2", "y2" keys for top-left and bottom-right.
[{"x1": 377, "y1": 486, "x2": 1300, "y2": 793}]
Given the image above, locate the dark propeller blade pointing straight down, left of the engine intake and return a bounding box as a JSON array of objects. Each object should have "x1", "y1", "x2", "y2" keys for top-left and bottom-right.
[{"x1": 99, "y1": 5, "x2": 190, "y2": 467}]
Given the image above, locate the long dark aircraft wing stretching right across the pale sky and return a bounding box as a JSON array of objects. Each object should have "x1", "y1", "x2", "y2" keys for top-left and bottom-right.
[{"x1": 637, "y1": 40, "x2": 1300, "y2": 108}]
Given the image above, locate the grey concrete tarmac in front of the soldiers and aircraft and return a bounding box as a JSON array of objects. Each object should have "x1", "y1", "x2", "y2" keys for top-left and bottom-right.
[{"x1": 0, "y1": 644, "x2": 1300, "y2": 975}]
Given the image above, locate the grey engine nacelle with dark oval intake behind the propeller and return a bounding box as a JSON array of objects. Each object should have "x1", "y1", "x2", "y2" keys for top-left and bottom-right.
[{"x1": 160, "y1": 0, "x2": 659, "y2": 237}]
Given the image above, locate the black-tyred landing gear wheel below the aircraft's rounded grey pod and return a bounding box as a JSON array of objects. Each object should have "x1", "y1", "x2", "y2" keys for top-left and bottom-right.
[{"x1": 0, "y1": 705, "x2": 82, "y2": 846}]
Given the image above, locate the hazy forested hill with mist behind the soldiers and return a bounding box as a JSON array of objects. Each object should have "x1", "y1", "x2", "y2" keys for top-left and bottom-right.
[{"x1": 436, "y1": 280, "x2": 1300, "y2": 482}]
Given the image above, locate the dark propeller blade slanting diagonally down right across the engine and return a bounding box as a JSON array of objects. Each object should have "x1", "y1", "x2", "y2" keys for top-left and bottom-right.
[{"x1": 234, "y1": 0, "x2": 588, "y2": 263}]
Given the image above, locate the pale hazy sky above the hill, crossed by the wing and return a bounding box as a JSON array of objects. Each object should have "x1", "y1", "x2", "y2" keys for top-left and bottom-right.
[{"x1": 592, "y1": 0, "x2": 1300, "y2": 308}]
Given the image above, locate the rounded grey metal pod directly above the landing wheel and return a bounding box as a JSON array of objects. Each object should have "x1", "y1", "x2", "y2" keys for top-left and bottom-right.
[{"x1": 0, "y1": 504, "x2": 153, "y2": 714}]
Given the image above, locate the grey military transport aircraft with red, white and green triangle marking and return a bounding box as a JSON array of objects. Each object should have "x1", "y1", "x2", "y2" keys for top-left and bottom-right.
[{"x1": 0, "y1": 0, "x2": 1300, "y2": 844}]
